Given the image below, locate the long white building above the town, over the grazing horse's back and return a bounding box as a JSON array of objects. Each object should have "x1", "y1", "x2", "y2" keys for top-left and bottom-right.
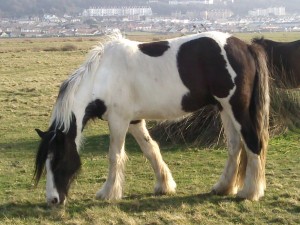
[{"x1": 82, "y1": 6, "x2": 152, "y2": 17}]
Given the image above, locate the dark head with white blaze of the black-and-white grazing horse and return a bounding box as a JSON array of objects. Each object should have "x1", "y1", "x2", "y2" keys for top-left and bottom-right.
[{"x1": 35, "y1": 126, "x2": 81, "y2": 205}]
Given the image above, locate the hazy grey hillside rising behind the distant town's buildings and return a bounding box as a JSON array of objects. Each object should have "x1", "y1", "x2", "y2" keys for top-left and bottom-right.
[{"x1": 0, "y1": 0, "x2": 300, "y2": 18}]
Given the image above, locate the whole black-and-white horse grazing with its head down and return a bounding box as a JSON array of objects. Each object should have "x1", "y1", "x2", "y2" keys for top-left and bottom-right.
[{"x1": 35, "y1": 32, "x2": 269, "y2": 205}]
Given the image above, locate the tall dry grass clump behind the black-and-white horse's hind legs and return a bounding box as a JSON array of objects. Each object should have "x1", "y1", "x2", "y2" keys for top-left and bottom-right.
[{"x1": 151, "y1": 81, "x2": 300, "y2": 146}]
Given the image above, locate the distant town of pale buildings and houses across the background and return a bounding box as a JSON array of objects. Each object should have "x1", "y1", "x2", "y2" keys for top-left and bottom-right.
[{"x1": 0, "y1": 0, "x2": 300, "y2": 38}]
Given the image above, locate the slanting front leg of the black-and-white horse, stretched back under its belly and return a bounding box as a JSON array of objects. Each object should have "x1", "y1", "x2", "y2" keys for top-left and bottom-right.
[{"x1": 129, "y1": 120, "x2": 176, "y2": 194}]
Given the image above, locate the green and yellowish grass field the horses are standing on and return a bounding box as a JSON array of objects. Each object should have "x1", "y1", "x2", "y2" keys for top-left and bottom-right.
[{"x1": 0, "y1": 33, "x2": 300, "y2": 224}]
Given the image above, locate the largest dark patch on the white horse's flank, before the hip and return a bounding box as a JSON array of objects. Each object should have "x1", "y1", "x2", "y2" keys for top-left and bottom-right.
[{"x1": 177, "y1": 37, "x2": 234, "y2": 112}]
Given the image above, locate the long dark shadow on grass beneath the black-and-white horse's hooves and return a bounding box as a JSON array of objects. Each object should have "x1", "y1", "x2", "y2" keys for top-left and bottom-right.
[{"x1": 0, "y1": 193, "x2": 242, "y2": 221}]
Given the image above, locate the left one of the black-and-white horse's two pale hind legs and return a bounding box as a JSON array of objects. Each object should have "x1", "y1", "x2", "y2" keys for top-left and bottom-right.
[{"x1": 212, "y1": 110, "x2": 241, "y2": 195}]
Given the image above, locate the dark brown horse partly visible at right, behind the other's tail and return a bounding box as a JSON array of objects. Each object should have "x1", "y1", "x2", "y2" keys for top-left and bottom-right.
[{"x1": 252, "y1": 38, "x2": 300, "y2": 88}]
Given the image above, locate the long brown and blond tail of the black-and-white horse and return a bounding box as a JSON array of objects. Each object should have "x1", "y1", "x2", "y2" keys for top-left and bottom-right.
[{"x1": 237, "y1": 43, "x2": 270, "y2": 190}]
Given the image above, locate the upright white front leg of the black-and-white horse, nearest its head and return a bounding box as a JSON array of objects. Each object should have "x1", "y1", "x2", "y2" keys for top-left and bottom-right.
[{"x1": 96, "y1": 116, "x2": 129, "y2": 200}]
